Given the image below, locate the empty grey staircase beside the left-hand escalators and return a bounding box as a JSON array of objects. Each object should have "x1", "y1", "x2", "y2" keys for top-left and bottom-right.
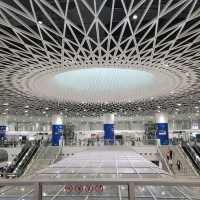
[{"x1": 24, "y1": 146, "x2": 61, "y2": 176}]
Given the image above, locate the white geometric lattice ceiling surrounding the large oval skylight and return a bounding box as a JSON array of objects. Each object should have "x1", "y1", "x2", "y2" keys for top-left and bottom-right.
[{"x1": 0, "y1": 0, "x2": 200, "y2": 116}]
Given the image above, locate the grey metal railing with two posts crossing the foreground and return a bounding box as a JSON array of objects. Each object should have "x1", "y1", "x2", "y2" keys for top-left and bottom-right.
[{"x1": 0, "y1": 178, "x2": 200, "y2": 200}]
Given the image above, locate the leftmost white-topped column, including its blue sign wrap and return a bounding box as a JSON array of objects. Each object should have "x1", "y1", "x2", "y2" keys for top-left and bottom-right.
[{"x1": 51, "y1": 115, "x2": 64, "y2": 146}]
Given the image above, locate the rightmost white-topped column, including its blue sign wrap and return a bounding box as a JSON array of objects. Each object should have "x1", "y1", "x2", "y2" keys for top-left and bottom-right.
[{"x1": 156, "y1": 113, "x2": 169, "y2": 145}]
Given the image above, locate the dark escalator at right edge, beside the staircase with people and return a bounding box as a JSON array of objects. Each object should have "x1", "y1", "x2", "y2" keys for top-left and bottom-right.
[{"x1": 182, "y1": 143, "x2": 200, "y2": 174}]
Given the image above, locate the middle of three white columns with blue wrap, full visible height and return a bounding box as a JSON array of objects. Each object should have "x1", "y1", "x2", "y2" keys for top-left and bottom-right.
[{"x1": 104, "y1": 113, "x2": 115, "y2": 144}]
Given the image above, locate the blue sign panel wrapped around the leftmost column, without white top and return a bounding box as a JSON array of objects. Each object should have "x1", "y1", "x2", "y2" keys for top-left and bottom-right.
[{"x1": 51, "y1": 125, "x2": 64, "y2": 146}]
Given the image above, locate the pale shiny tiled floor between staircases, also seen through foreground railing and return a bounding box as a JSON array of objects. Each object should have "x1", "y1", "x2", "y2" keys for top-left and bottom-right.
[{"x1": 0, "y1": 147, "x2": 200, "y2": 200}]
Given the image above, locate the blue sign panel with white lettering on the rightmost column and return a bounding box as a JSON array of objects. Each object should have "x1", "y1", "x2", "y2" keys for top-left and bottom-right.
[{"x1": 156, "y1": 123, "x2": 169, "y2": 145}]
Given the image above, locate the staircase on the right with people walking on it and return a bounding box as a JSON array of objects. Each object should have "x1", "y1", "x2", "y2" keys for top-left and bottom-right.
[{"x1": 159, "y1": 145, "x2": 198, "y2": 176}]
